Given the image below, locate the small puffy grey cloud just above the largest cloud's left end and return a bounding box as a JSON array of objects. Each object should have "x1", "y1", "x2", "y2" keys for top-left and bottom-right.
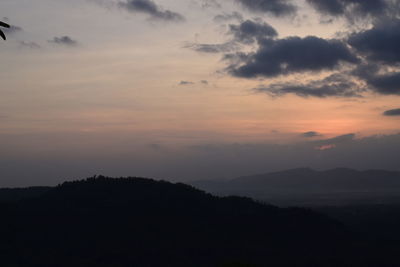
[{"x1": 229, "y1": 20, "x2": 278, "y2": 44}]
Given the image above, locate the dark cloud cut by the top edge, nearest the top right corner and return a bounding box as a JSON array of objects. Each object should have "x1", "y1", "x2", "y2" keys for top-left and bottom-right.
[{"x1": 307, "y1": 0, "x2": 390, "y2": 19}]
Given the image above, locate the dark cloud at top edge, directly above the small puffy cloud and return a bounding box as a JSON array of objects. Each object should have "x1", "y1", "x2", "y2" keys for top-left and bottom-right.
[{"x1": 236, "y1": 0, "x2": 297, "y2": 17}]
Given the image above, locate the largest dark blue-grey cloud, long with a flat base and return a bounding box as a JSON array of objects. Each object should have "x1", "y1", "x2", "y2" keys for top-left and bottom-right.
[{"x1": 227, "y1": 36, "x2": 359, "y2": 78}]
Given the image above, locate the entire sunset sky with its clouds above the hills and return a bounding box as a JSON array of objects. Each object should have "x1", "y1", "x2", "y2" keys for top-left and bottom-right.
[{"x1": 0, "y1": 0, "x2": 400, "y2": 187}]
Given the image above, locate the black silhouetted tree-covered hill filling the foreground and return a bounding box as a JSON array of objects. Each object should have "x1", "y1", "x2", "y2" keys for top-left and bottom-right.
[{"x1": 0, "y1": 176, "x2": 399, "y2": 267}]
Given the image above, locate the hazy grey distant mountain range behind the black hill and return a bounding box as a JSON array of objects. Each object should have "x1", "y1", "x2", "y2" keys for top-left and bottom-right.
[{"x1": 191, "y1": 168, "x2": 400, "y2": 206}]
